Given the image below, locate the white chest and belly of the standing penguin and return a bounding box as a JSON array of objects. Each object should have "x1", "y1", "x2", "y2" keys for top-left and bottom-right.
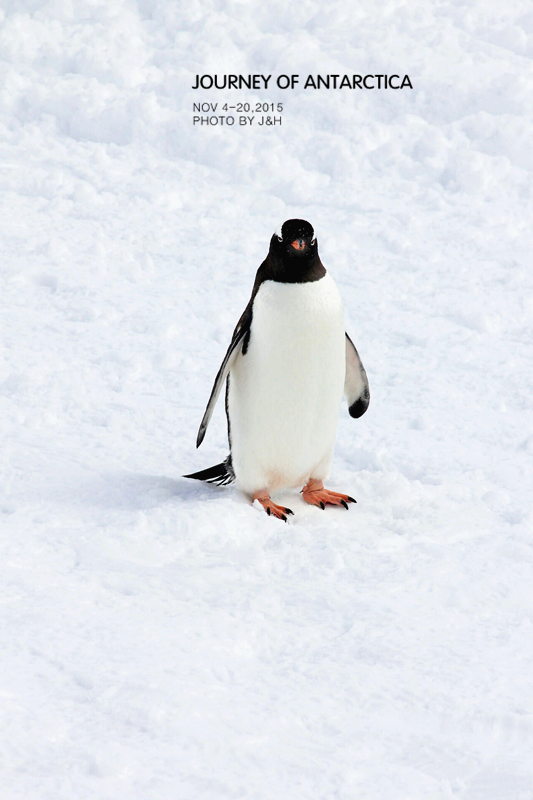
[{"x1": 228, "y1": 274, "x2": 346, "y2": 486}]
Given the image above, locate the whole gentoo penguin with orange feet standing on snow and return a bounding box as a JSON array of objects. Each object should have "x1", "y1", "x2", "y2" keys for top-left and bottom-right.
[{"x1": 184, "y1": 219, "x2": 370, "y2": 521}]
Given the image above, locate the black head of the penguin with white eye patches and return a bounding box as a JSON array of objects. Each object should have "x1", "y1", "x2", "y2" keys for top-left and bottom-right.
[{"x1": 269, "y1": 219, "x2": 319, "y2": 282}]
